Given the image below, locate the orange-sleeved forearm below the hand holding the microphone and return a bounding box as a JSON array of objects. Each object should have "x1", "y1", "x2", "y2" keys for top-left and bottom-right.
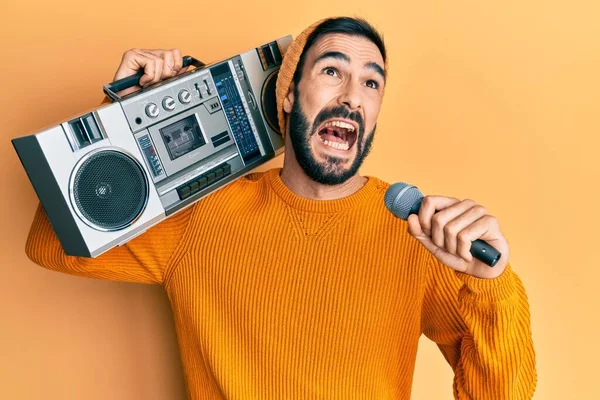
[{"x1": 454, "y1": 267, "x2": 537, "y2": 400}]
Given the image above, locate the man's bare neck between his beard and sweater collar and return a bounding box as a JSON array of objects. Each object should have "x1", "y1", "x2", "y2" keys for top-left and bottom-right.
[{"x1": 281, "y1": 151, "x2": 367, "y2": 200}]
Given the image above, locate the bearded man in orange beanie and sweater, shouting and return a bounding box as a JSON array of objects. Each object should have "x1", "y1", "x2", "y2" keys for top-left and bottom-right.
[{"x1": 27, "y1": 18, "x2": 536, "y2": 400}]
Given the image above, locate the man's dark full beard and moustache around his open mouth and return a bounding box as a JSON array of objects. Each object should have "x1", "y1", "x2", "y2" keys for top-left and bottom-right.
[{"x1": 289, "y1": 90, "x2": 377, "y2": 186}]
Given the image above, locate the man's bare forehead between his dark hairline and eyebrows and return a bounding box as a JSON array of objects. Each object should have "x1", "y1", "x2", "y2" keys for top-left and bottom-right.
[{"x1": 306, "y1": 33, "x2": 384, "y2": 67}]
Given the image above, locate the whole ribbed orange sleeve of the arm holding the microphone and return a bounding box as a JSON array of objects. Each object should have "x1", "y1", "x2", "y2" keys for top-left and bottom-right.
[{"x1": 422, "y1": 257, "x2": 537, "y2": 400}]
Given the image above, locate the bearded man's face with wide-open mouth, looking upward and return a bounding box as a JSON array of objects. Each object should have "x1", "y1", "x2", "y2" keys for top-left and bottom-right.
[{"x1": 284, "y1": 34, "x2": 385, "y2": 185}]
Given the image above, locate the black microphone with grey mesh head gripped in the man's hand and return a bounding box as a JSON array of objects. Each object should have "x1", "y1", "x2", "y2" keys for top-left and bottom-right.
[{"x1": 384, "y1": 182, "x2": 501, "y2": 267}]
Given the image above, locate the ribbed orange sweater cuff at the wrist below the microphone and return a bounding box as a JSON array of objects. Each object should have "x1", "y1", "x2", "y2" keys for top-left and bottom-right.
[{"x1": 456, "y1": 263, "x2": 517, "y2": 304}]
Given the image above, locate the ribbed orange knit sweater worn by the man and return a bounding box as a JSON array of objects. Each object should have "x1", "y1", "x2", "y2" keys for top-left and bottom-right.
[{"x1": 27, "y1": 169, "x2": 536, "y2": 400}]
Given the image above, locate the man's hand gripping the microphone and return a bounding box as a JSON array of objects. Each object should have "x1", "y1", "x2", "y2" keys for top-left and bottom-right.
[{"x1": 408, "y1": 196, "x2": 508, "y2": 279}]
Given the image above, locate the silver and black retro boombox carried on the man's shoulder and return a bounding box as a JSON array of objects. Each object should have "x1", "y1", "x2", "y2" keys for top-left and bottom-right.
[{"x1": 12, "y1": 35, "x2": 292, "y2": 257}]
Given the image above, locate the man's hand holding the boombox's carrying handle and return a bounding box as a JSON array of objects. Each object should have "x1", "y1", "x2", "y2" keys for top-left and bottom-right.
[{"x1": 113, "y1": 49, "x2": 188, "y2": 96}]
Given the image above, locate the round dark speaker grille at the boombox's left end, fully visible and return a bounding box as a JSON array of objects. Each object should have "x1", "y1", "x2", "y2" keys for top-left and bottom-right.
[{"x1": 71, "y1": 150, "x2": 148, "y2": 231}]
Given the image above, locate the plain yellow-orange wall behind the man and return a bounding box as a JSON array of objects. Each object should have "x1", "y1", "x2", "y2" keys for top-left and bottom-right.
[{"x1": 0, "y1": 0, "x2": 600, "y2": 400}]
